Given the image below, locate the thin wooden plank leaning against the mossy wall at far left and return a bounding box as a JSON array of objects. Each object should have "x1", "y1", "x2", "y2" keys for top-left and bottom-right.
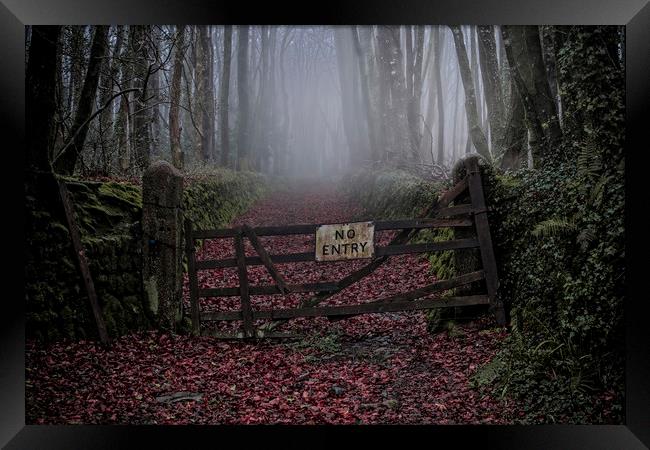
[{"x1": 58, "y1": 182, "x2": 110, "y2": 345}]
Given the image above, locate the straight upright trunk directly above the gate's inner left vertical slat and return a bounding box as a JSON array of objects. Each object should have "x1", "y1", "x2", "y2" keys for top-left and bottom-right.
[{"x1": 237, "y1": 25, "x2": 250, "y2": 170}]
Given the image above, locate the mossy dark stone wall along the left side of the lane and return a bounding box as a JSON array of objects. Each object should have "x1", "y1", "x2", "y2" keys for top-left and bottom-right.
[{"x1": 25, "y1": 170, "x2": 268, "y2": 341}]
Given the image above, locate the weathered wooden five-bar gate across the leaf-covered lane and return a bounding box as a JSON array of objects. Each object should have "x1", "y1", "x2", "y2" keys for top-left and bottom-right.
[{"x1": 185, "y1": 158, "x2": 505, "y2": 338}]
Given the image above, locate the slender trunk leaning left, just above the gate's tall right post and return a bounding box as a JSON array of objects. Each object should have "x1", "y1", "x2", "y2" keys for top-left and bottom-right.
[{"x1": 450, "y1": 26, "x2": 490, "y2": 158}]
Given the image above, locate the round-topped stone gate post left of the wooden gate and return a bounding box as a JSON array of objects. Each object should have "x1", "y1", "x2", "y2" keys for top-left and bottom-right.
[{"x1": 142, "y1": 161, "x2": 183, "y2": 331}]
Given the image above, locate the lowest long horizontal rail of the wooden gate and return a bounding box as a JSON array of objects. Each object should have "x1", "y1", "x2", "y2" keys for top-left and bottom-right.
[{"x1": 201, "y1": 295, "x2": 489, "y2": 321}]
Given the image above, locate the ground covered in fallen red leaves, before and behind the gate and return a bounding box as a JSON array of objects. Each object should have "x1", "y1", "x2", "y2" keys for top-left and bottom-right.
[{"x1": 26, "y1": 181, "x2": 523, "y2": 424}]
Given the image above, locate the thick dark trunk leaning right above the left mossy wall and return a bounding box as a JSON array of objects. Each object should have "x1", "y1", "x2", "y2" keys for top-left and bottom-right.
[{"x1": 55, "y1": 25, "x2": 108, "y2": 175}]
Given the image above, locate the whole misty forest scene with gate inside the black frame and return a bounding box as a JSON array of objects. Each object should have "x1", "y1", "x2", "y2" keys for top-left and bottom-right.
[{"x1": 25, "y1": 25, "x2": 625, "y2": 424}]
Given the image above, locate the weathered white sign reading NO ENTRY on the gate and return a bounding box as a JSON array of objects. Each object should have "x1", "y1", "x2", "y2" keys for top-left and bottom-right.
[{"x1": 316, "y1": 222, "x2": 375, "y2": 261}]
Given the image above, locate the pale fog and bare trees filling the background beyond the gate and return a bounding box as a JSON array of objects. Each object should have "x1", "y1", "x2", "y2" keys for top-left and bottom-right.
[{"x1": 34, "y1": 25, "x2": 527, "y2": 178}]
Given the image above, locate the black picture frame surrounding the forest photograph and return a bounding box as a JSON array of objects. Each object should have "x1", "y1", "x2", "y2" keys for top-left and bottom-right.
[{"x1": 6, "y1": 0, "x2": 650, "y2": 449}]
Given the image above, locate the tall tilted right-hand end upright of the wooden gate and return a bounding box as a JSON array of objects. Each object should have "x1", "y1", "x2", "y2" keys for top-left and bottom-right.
[{"x1": 465, "y1": 158, "x2": 506, "y2": 326}]
